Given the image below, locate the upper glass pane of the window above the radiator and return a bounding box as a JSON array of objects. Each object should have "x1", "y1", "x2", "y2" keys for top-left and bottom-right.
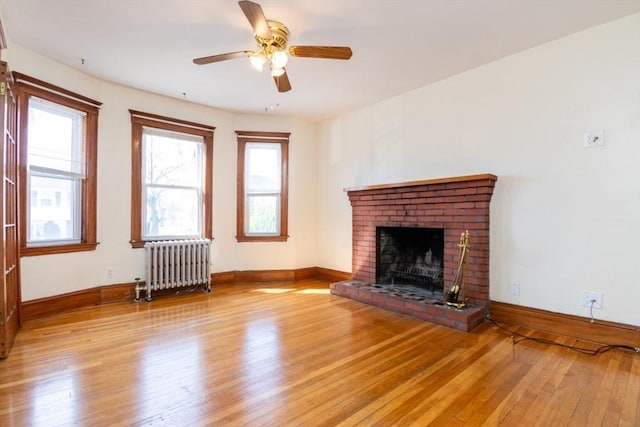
[{"x1": 143, "y1": 129, "x2": 204, "y2": 187}]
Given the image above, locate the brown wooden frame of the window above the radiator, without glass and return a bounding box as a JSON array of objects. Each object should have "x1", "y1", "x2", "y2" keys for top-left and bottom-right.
[{"x1": 129, "y1": 110, "x2": 215, "y2": 248}]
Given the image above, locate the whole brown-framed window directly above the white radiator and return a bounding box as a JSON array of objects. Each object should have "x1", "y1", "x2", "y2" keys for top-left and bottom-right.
[{"x1": 129, "y1": 110, "x2": 215, "y2": 247}]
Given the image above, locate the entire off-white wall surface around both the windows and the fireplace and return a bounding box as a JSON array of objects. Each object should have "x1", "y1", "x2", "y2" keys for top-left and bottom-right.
[{"x1": 3, "y1": 15, "x2": 640, "y2": 325}]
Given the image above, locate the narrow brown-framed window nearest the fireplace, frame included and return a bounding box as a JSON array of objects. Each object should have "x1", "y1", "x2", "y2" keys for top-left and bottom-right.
[{"x1": 236, "y1": 131, "x2": 290, "y2": 242}]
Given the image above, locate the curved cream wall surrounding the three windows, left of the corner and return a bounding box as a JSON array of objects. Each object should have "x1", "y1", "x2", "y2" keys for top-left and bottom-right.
[{"x1": 3, "y1": 44, "x2": 317, "y2": 301}]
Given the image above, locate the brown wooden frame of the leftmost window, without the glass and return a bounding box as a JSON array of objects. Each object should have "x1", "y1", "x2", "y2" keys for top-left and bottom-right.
[{"x1": 13, "y1": 71, "x2": 102, "y2": 256}]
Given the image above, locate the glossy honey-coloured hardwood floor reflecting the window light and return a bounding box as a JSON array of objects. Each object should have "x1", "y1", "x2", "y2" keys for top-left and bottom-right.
[{"x1": 0, "y1": 280, "x2": 640, "y2": 426}]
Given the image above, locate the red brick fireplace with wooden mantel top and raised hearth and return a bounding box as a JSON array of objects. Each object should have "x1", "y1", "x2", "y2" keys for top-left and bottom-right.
[{"x1": 331, "y1": 174, "x2": 497, "y2": 331}]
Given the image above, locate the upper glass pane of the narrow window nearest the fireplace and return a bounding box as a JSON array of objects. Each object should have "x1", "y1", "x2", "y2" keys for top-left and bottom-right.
[{"x1": 245, "y1": 143, "x2": 282, "y2": 193}]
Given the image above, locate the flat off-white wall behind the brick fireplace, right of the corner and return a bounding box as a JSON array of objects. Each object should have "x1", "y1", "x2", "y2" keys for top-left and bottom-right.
[{"x1": 318, "y1": 15, "x2": 640, "y2": 325}]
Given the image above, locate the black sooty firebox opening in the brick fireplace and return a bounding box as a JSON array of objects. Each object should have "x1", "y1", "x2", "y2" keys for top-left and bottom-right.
[{"x1": 376, "y1": 227, "x2": 444, "y2": 300}]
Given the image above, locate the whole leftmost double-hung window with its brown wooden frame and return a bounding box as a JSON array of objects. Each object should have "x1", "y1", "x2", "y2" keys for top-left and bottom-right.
[{"x1": 13, "y1": 72, "x2": 101, "y2": 256}]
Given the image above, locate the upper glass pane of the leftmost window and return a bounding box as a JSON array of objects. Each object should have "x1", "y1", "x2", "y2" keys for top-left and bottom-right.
[{"x1": 27, "y1": 97, "x2": 86, "y2": 176}]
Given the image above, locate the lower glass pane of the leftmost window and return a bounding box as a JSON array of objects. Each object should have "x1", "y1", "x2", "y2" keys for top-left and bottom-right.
[{"x1": 27, "y1": 176, "x2": 79, "y2": 243}]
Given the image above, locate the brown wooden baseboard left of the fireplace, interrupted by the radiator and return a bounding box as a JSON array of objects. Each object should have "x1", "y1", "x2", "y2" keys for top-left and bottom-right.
[{"x1": 20, "y1": 267, "x2": 351, "y2": 322}]
